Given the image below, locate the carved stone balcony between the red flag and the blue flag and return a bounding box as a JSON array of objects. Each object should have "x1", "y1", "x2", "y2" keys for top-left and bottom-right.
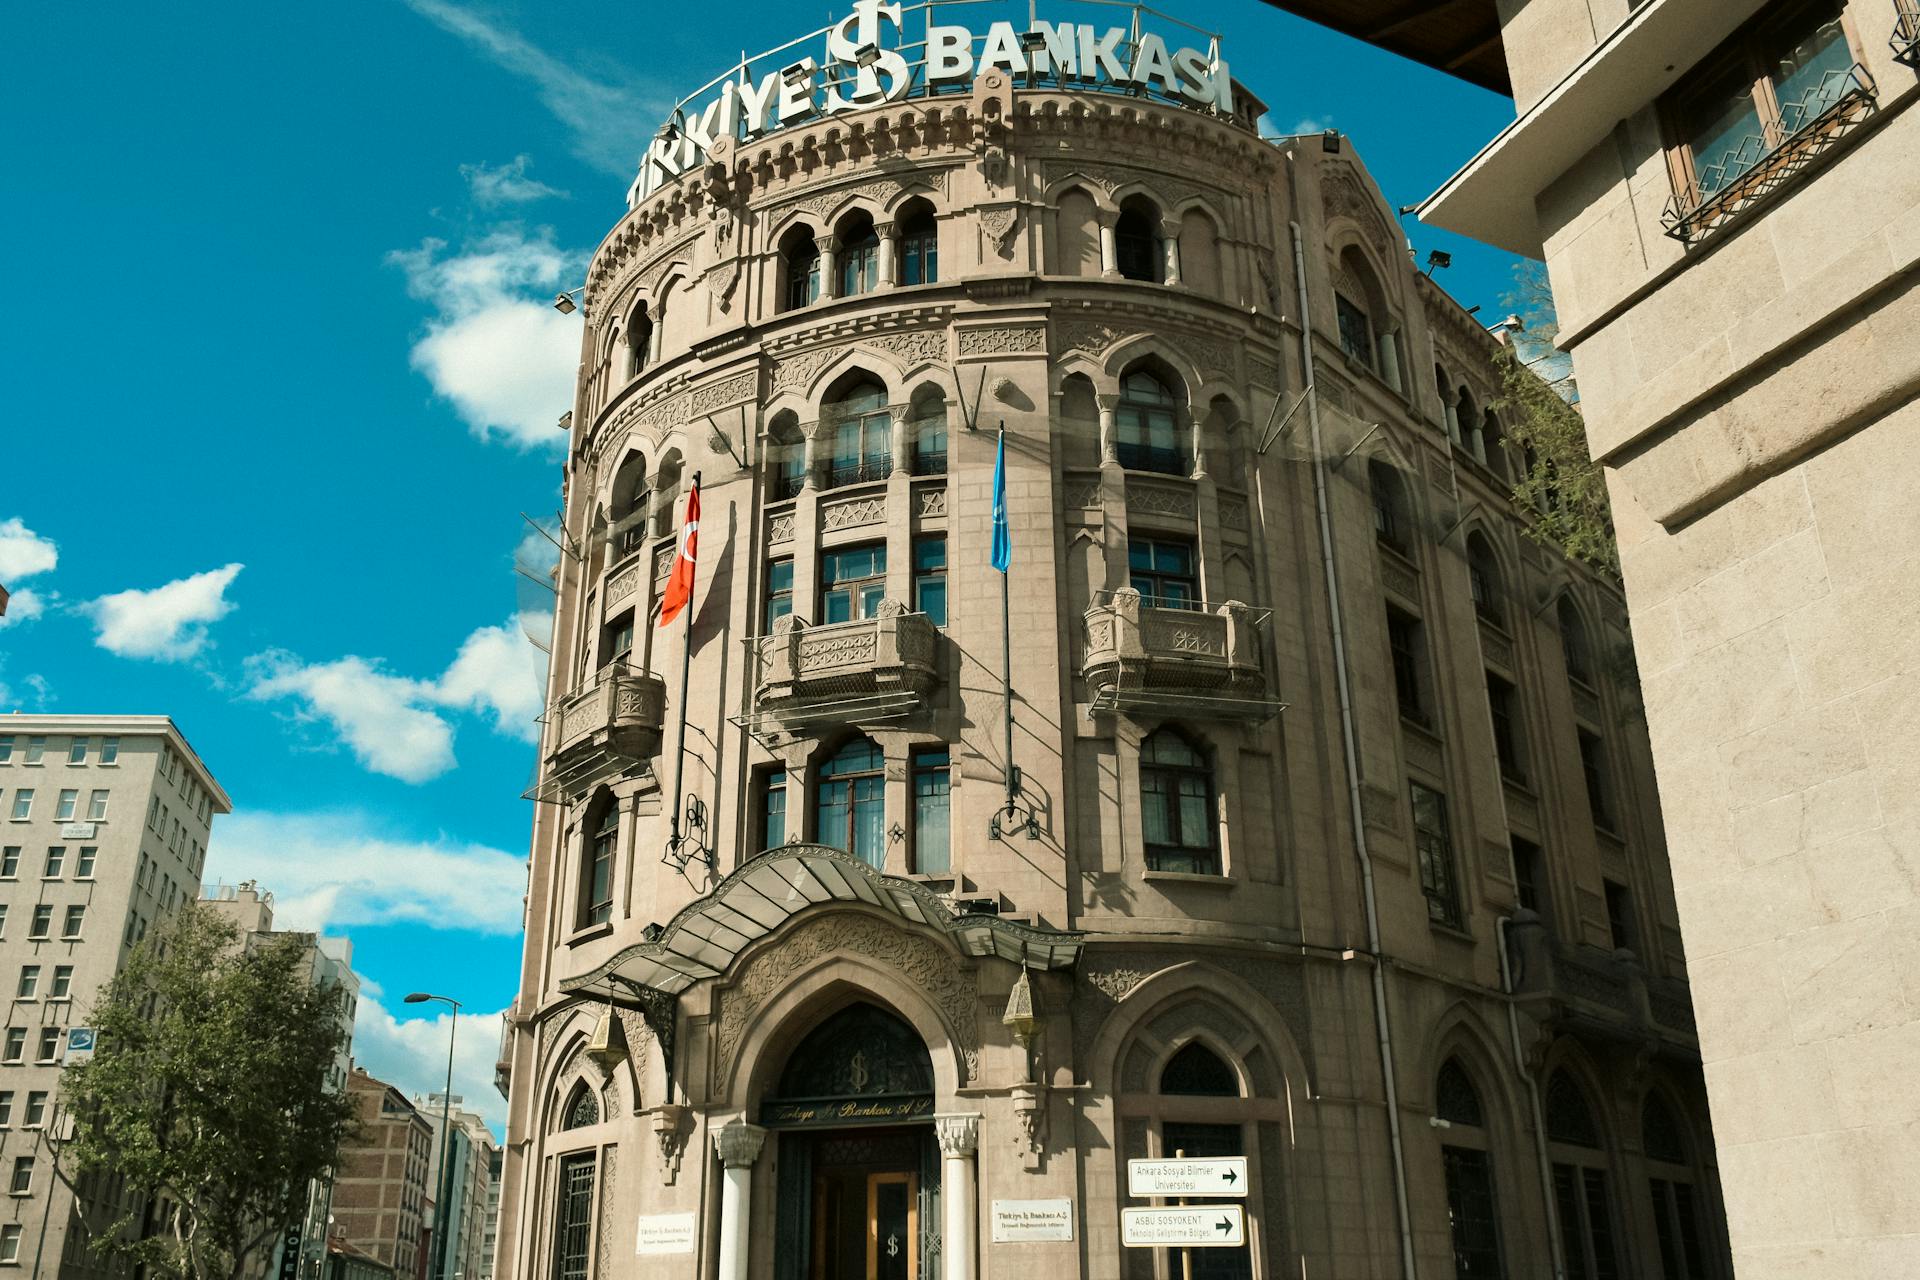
[{"x1": 747, "y1": 601, "x2": 939, "y2": 733}]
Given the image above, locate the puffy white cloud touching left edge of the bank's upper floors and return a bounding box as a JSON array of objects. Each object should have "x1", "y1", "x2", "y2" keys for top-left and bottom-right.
[{"x1": 388, "y1": 228, "x2": 580, "y2": 449}]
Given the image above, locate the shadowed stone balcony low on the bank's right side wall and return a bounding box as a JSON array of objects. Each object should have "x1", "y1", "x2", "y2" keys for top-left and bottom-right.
[{"x1": 1507, "y1": 912, "x2": 1699, "y2": 1052}]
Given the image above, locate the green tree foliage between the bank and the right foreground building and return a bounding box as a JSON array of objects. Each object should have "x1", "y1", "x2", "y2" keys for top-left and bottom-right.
[{"x1": 1492, "y1": 263, "x2": 1620, "y2": 578}]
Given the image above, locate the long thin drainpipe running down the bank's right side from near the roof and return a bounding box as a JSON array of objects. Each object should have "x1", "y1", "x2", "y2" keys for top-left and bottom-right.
[{"x1": 1286, "y1": 192, "x2": 1419, "y2": 1280}]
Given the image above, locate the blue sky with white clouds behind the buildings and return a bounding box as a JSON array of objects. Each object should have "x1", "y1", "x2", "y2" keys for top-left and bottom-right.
[{"x1": 0, "y1": 0, "x2": 1511, "y2": 1123}]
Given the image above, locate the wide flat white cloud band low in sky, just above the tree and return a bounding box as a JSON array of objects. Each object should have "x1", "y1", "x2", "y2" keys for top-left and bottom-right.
[{"x1": 204, "y1": 810, "x2": 526, "y2": 936}]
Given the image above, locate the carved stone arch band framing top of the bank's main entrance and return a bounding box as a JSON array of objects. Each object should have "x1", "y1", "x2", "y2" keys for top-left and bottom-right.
[{"x1": 714, "y1": 912, "x2": 979, "y2": 1082}]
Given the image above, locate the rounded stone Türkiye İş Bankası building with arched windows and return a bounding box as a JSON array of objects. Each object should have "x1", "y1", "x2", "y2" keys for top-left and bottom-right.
[{"x1": 499, "y1": 8, "x2": 1726, "y2": 1280}]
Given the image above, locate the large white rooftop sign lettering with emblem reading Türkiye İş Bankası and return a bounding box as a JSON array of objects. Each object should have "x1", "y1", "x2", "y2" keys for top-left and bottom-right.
[{"x1": 628, "y1": 0, "x2": 1233, "y2": 207}]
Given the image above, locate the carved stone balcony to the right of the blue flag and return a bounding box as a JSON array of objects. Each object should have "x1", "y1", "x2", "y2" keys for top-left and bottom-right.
[{"x1": 1081, "y1": 589, "x2": 1283, "y2": 720}]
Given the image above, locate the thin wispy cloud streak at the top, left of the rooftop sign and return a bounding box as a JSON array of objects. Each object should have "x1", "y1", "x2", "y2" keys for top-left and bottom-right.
[{"x1": 407, "y1": 0, "x2": 666, "y2": 180}]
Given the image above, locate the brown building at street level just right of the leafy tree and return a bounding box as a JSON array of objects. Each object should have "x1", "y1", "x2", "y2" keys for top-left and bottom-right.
[{"x1": 343, "y1": 1067, "x2": 434, "y2": 1280}]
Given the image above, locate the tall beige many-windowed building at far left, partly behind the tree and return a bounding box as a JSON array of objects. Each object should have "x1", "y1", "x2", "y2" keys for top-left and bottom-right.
[{"x1": 0, "y1": 716, "x2": 232, "y2": 1278}]
